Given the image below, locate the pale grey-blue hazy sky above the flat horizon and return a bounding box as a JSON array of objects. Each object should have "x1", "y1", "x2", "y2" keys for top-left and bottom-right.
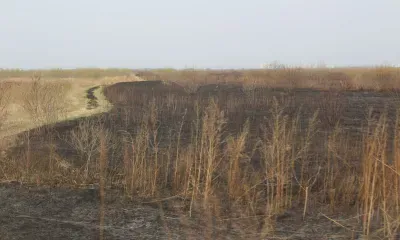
[{"x1": 0, "y1": 0, "x2": 400, "y2": 68}]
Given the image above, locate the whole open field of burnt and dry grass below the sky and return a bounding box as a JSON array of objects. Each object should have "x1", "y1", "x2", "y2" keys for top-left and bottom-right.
[{"x1": 0, "y1": 67, "x2": 400, "y2": 239}]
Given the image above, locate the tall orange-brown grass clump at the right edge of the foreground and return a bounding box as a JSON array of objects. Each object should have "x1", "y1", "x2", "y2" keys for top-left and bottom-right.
[{"x1": 360, "y1": 110, "x2": 400, "y2": 239}]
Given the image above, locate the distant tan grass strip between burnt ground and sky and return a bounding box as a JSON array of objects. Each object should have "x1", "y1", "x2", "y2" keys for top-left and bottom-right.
[{"x1": 136, "y1": 66, "x2": 400, "y2": 91}]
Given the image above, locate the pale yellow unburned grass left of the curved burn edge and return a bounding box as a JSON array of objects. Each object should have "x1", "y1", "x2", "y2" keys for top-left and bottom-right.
[{"x1": 0, "y1": 70, "x2": 141, "y2": 137}]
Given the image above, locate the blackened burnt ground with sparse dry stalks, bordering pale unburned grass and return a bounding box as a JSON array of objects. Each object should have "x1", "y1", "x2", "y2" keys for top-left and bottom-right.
[{"x1": 0, "y1": 80, "x2": 400, "y2": 239}]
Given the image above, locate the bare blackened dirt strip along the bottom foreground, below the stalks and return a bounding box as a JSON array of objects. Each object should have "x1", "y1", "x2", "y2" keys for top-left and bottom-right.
[{"x1": 0, "y1": 182, "x2": 366, "y2": 240}]
